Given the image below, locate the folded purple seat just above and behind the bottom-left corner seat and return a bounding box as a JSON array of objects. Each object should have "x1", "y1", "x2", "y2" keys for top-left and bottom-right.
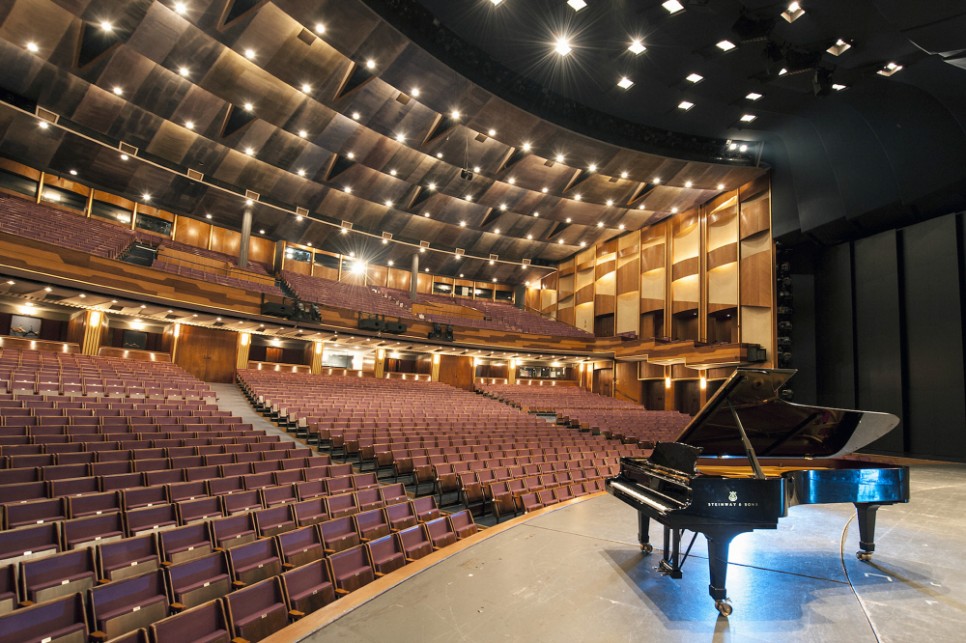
[{"x1": 19, "y1": 549, "x2": 97, "y2": 603}]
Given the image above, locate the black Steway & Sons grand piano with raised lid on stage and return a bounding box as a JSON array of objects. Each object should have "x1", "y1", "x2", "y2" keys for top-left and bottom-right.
[{"x1": 607, "y1": 368, "x2": 909, "y2": 616}]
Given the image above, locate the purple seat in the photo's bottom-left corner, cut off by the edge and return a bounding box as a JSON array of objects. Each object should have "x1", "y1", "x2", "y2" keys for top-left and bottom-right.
[{"x1": 0, "y1": 593, "x2": 90, "y2": 643}]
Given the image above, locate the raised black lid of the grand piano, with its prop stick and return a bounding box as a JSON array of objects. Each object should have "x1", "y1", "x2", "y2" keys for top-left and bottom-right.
[{"x1": 677, "y1": 368, "x2": 899, "y2": 458}]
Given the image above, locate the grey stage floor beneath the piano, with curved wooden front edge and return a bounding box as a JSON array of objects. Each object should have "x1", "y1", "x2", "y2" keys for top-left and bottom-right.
[{"x1": 273, "y1": 465, "x2": 966, "y2": 643}]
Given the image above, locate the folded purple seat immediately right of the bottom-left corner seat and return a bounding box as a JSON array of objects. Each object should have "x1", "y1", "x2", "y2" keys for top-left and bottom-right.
[{"x1": 87, "y1": 570, "x2": 169, "y2": 641}]
